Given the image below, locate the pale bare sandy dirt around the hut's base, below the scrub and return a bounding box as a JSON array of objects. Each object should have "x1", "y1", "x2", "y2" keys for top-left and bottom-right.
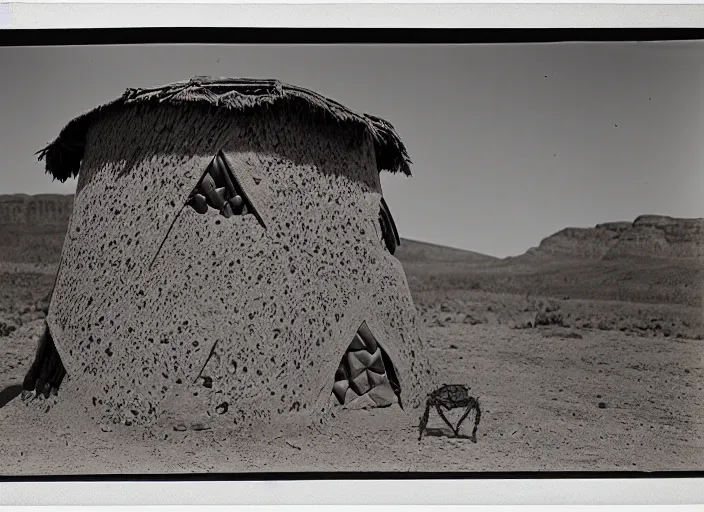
[{"x1": 0, "y1": 314, "x2": 704, "y2": 475}]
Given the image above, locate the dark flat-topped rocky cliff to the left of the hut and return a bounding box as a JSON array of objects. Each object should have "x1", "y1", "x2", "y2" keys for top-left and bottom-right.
[{"x1": 0, "y1": 194, "x2": 73, "y2": 263}]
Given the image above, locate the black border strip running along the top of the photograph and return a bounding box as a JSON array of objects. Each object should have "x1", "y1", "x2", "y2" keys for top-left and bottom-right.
[{"x1": 0, "y1": 27, "x2": 704, "y2": 46}]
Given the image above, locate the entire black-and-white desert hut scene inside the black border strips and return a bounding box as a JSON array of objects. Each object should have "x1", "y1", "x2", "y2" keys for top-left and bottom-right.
[{"x1": 0, "y1": 41, "x2": 704, "y2": 476}]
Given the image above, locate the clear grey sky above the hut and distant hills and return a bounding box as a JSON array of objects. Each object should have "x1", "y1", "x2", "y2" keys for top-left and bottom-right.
[{"x1": 0, "y1": 43, "x2": 704, "y2": 256}]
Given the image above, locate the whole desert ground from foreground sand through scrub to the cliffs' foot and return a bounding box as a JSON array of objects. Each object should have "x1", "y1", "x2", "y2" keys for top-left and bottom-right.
[{"x1": 0, "y1": 195, "x2": 704, "y2": 475}]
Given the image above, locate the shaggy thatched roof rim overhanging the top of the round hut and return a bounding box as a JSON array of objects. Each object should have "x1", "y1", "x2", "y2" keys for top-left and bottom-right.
[{"x1": 37, "y1": 77, "x2": 411, "y2": 182}]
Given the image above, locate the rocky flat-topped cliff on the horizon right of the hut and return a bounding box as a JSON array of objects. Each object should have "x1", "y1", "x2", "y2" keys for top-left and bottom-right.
[{"x1": 519, "y1": 215, "x2": 704, "y2": 260}]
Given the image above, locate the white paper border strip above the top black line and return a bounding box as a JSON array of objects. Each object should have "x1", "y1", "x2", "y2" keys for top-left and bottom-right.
[{"x1": 0, "y1": 0, "x2": 704, "y2": 29}]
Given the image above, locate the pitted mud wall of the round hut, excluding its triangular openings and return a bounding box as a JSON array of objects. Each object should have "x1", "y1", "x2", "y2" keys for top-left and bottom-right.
[{"x1": 49, "y1": 103, "x2": 435, "y2": 424}]
